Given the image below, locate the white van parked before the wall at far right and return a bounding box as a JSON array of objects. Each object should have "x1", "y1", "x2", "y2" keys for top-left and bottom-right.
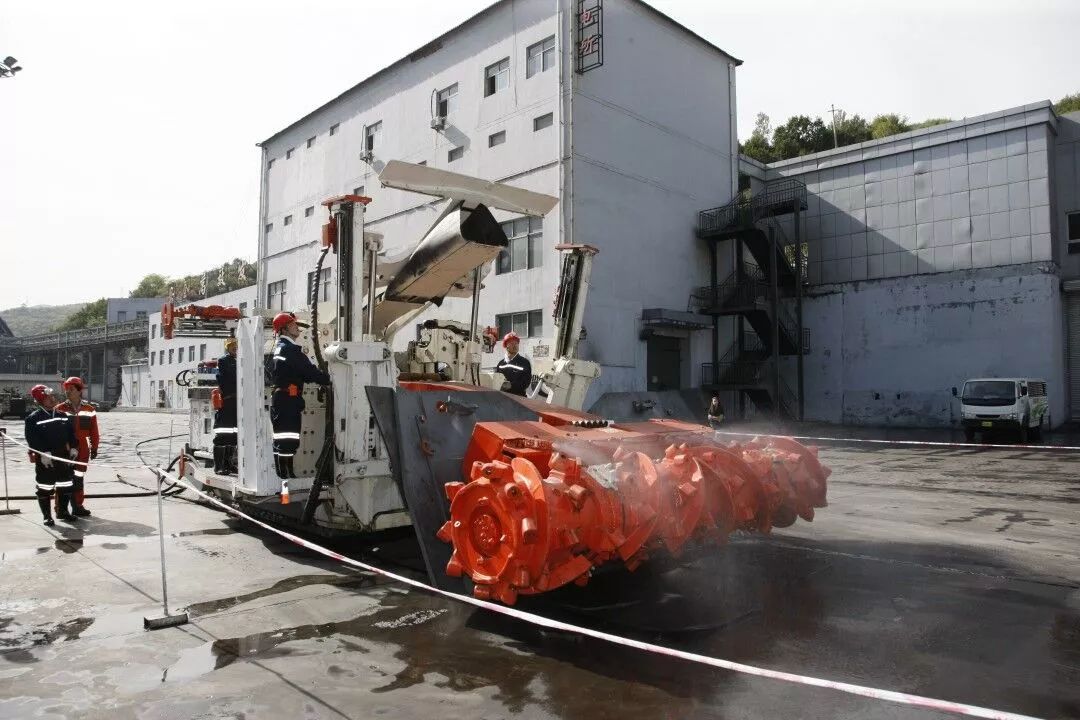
[{"x1": 960, "y1": 378, "x2": 1048, "y2": 443}]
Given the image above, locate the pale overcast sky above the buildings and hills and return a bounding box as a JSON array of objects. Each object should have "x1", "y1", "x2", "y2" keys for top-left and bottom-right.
[{"x1": 0, "y1": 0, "x2": 1080, "y2": 309}]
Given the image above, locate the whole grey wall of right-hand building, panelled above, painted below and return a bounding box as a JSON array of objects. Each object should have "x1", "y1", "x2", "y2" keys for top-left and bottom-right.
[{"x1": 770, "y1": 103, "x2": 1067, "y2": 426}]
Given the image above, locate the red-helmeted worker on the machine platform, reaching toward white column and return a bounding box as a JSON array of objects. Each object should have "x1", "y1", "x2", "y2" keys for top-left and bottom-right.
[{"x1": 270, "y1": 312, "x2": 330, "y2": 479}]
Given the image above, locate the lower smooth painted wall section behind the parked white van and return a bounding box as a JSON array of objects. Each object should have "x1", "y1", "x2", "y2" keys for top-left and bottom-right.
[{"x1": 804, "y1": 264, "x2": 1067, "y2": 426}]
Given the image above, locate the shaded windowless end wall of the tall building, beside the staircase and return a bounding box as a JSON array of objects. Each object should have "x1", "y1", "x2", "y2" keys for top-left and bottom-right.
[{"x1": 572, "y1": 0, "x2": 738, "y2": 399}]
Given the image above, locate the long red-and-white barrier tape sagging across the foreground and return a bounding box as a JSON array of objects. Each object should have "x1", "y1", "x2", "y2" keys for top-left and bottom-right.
[{"x1": 158, "y1": 468, "x2": 1038, "y2": 720}]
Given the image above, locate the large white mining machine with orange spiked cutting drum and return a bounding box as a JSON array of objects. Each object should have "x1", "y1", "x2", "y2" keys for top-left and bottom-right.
[{"x1": 164, "y1": 161, "x2": 828, "y2": 603}]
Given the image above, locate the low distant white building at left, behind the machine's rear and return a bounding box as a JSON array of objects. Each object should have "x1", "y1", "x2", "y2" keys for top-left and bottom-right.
[{"x1": 140, "y1": 285, "x2": 256, "y2": 408}]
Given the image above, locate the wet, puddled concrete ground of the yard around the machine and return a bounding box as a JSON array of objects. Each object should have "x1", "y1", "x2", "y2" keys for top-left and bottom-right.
[{"x1": 0, "y1": 413, "x2": 1080, "y2": 720}]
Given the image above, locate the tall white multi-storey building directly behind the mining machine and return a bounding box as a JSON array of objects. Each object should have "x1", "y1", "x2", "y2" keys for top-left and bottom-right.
[{"x1": 254, "y1": 0, "x2": 740, "y2": 402}]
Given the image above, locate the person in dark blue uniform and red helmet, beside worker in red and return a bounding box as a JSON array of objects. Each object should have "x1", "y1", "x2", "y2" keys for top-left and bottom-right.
[{"x1": 25, "y1": 385, "x2": 79, "y2": 527}]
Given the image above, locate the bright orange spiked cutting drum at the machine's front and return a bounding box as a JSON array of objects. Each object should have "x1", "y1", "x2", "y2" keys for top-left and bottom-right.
[{"x1": 438, "y1": 421, "x2": 829, "y2": 604}]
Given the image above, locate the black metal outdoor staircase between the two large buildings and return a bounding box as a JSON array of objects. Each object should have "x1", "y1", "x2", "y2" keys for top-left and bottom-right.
[{"x1": 688, "y1": 178, "x2": 806, "y2": 419}]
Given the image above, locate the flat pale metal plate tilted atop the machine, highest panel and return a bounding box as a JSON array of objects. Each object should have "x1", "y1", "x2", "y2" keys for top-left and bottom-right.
[{"x1": 379, "y1": 160, "x2": 558, "y2": 217}]
